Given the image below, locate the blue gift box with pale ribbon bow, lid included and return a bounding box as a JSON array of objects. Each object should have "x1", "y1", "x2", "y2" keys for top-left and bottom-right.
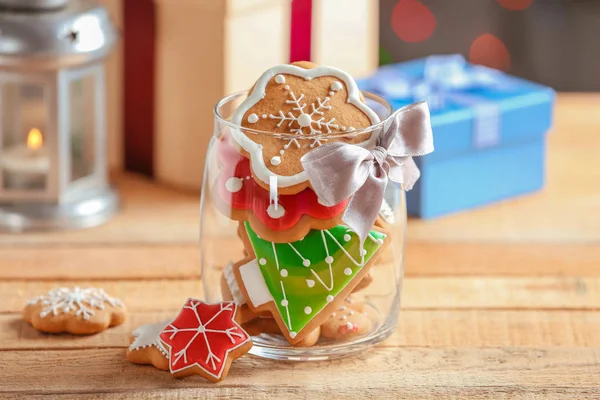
[{"x1": 358, "y1": 55, "x2": 555, "y2": 218}]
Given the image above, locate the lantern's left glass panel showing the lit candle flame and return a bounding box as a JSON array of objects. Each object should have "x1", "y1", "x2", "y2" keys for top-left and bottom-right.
[{"x1": 0, "y1": 82, "x2": 50, "y2": 192}]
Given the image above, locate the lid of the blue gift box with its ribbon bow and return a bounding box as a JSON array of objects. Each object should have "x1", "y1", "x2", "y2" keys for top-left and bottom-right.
[{"x1": 358, "y1": 55, "x2": 555, "y2": 160}]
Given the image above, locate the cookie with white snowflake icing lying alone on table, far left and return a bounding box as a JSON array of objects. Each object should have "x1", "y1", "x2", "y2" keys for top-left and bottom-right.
[{"x1": 23, "y1": 287, "x2": 126, "y2": 335}]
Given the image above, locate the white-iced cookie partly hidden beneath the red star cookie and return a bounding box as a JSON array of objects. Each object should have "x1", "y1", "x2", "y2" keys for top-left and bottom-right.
[{"x1": 126, "y1": 321, "x2": 171, "y2": 371}]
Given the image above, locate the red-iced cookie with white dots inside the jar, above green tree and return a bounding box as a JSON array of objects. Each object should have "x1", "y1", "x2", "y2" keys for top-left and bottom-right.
[{"x1": 213, "y1": 139, "x2": 348, "y2": 243}]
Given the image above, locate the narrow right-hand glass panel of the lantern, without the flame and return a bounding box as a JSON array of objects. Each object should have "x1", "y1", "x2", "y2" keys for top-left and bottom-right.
[{"x1": 69, "y1": 75, "x2": 97, "y2": 181}]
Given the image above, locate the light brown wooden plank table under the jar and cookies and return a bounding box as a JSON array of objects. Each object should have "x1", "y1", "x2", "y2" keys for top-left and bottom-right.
[{"x1": 0, "y1": 95, "x2": 600, "y2": 400}]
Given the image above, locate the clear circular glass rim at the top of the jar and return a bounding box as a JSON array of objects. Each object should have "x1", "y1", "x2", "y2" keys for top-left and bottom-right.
[{"x1": 213, "y1": 90, "x2": 394, "y2": 140}]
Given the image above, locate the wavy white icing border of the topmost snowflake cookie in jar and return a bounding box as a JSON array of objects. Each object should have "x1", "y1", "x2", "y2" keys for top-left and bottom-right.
[{"x1": 231, "y1": 65, "x2": 379, "y2": 187}]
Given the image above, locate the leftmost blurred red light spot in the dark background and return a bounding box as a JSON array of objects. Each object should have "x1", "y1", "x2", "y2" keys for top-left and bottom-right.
[{"x1": 392, "y1": 0, "x2": 436, "y2": 43}]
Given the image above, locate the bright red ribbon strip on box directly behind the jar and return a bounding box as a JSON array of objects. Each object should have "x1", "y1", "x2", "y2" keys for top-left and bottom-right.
[{"x1": 290, "y1": 0, "x2": 313, "y2": 62}]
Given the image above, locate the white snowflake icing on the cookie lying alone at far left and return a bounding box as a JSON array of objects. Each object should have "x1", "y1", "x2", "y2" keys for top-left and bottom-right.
[{"x1": 27, "y1": 287, "x2": 123, "y2": 320}]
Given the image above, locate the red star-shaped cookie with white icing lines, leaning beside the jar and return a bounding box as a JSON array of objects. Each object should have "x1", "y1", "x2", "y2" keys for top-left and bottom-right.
[{"x1": 159, "y1": 299, "x2": 252, "y2": 382}]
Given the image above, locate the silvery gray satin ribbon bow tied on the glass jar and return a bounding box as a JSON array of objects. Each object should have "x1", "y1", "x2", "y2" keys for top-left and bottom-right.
[{"x1": 300, "y1": 102, "x2": 433, "y2": 245}]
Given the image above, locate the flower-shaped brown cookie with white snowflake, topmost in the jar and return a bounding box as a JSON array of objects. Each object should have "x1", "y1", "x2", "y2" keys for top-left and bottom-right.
[{"x1": 231, "y1": 62, "x2": 379, "y2": 194}]
